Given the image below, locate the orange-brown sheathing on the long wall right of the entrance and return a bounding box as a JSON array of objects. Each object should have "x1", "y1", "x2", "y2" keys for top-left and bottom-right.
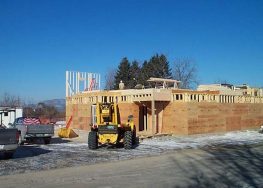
[{"x1": 162, "y1": 103, "x2": 263, "y2": 135}]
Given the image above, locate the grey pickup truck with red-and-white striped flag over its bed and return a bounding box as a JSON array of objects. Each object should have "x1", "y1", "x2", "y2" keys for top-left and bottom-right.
[{"x1": 13, "y1": 117, "x2": 54, "y2": 144}]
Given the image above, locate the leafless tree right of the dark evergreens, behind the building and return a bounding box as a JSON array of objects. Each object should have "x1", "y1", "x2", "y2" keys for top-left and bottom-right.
[{"x1": 173, "y1": 59, "x2": 198, "y2": 89}]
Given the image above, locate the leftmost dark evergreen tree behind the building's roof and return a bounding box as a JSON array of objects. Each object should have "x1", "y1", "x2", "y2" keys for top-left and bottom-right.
[{"x1": 114, "y1": 57, "x2": 131, "y2": 89}]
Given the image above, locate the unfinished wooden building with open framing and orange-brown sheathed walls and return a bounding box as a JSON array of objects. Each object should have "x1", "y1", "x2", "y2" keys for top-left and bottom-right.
[{"x1": 66, "y1": 72, "x2": 263, "y2": 135}]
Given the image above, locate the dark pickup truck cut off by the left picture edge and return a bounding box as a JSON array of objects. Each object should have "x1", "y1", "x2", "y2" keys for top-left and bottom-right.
[{"x1": 0, "y1": 125, "x2": 19, "y2": 159}]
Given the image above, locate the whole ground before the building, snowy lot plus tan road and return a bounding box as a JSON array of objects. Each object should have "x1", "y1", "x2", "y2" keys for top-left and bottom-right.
[{"x1": 0, "y1": 131, "x2": 263, "y2": 188}]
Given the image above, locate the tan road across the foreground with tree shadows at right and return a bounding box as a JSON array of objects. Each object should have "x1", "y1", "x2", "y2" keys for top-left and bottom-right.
[{"x1": 0, "y1": 142, "x2": 263, "y2": 188}]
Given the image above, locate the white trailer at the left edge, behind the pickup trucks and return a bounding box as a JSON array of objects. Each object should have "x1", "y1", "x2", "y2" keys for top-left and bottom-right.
[{"x1": 0, "y1": 107, "x2": 23, "y2": 128}]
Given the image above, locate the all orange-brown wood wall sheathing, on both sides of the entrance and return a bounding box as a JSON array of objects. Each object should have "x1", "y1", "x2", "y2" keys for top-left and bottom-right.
[{"x1": 66, "y1": 102, "x2": 263, "y2": 135}]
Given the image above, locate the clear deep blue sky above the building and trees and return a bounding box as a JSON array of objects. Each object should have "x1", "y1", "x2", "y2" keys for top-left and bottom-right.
[{"x1": 0, "y1": 0, "x2": 263, "y2": 100}]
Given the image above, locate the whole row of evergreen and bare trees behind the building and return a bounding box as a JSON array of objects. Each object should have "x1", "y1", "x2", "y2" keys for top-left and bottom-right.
[{"x1": 105, "y1": 54, "x2": 198, "y2": 90}]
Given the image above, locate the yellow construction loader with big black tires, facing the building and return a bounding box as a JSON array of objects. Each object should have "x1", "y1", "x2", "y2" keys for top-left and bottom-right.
[{"x1": 88, "y1": 103, "x2": 136, "y2": 149}]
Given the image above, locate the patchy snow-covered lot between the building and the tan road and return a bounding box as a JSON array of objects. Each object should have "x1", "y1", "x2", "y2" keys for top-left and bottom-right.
[{"x1": 0, "y1": 131, "x2": 263, "y2": 175}]
